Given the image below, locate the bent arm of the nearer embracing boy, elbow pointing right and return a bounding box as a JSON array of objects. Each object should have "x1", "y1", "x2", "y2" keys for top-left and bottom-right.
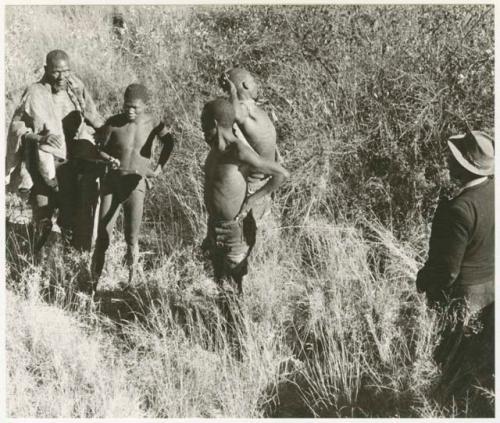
[{"x1": 231, "y1": 142, "x2": 290, "y2": 219}]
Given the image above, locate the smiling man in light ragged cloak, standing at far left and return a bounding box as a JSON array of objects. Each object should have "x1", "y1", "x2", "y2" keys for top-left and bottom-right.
[{"x1": 6, "y1": 50, "x2": 104, "y2": 250}]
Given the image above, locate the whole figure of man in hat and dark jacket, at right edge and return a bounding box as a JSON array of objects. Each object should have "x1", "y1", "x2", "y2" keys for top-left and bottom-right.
[{"x1": 417, "y1": 131, "x2": 495, "y2": 398}]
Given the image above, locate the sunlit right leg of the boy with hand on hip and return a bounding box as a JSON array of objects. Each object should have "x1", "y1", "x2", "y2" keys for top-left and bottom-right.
[{"x1": 123, "y1": 179, "x2": 146, "y2": 284}]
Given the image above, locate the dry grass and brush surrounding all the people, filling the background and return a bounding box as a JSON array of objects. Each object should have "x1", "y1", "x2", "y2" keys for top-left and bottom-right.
[{"x1": 5, "y1": 6, "x2": 494, "y2": 417}]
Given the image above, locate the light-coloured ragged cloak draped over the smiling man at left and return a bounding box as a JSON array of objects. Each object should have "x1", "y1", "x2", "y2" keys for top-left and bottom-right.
[{"x1": 5, "y1": 75, "x2": 104, "y2": 190}]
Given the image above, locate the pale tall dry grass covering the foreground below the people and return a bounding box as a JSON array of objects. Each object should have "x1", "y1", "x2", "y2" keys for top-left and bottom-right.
[{"x1": 7, "y1": 209, "x2": 462, "y2": 417}]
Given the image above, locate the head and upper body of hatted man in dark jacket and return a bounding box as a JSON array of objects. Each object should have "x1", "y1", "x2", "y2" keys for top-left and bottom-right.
[{"x1": 416, "y1": 131, "x2": 495, "y2": 311}]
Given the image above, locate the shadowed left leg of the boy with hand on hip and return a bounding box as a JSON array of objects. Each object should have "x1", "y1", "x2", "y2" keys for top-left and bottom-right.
[{"x1": 91, "y1": 192, "x2": 120, "y2": 284}]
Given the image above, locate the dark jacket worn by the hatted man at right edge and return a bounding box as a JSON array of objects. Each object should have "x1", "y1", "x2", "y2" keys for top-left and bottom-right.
[{"x1": 417, "y1": 179, "x2": 495, "y2": 306}]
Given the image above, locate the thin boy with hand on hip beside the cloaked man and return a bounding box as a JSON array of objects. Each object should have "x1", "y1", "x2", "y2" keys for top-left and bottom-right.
[{"x1": 92, "y1": 84, "x2": 174, "y2": 289}]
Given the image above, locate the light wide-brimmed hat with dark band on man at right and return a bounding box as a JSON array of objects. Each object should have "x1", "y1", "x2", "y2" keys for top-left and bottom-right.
[{"x1": 448, "y1": 130, "x2": 495, "y2": 176}]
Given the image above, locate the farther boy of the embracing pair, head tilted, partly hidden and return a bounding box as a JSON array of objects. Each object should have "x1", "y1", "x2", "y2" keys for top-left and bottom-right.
[{"x1": 220, "y1": 67, "x2": 280, "y2": 226}]
